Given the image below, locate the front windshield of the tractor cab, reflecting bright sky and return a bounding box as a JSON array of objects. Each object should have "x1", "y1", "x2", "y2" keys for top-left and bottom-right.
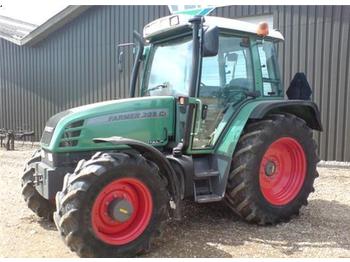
[{"x1": 143, "y1": 37, "x2": 192, "y2": 96}]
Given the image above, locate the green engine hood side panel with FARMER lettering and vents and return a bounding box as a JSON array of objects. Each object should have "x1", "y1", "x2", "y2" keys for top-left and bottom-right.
[{"x1": 41, "y1": 96, "x2": 175, "y2": 152}]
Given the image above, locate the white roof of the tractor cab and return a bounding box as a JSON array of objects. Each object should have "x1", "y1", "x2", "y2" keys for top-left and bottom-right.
[{"x1": 143, "y1": 14, "x2": 284, "y2": 40}]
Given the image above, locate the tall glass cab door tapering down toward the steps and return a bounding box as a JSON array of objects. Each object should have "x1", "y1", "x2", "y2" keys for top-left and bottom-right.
[{"x1": 191, "y1": 35, "x2": 254, "y2": 153}]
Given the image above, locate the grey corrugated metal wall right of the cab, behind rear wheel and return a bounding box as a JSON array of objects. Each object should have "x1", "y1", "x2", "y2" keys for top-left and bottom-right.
[{"x1": 213, "y1": 6, "x2": 350, "y2": 161}]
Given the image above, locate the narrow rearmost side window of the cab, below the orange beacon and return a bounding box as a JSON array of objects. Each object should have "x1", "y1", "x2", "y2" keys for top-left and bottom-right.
[{"x1": 258, "y1": 41, "x2": 281, "y2": 96}]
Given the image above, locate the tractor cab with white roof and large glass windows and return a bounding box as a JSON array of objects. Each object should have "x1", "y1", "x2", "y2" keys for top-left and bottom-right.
[{"x1": 136, "y1": 15, "x2": 284, "y2": 153}]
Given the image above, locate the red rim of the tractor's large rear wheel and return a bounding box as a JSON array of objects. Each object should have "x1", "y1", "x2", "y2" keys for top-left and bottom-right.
[{"x1": 259, "y1": 137, "x2": 307, "y2": 206}]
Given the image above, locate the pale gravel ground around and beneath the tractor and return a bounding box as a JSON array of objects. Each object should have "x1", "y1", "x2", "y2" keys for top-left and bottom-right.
[{"x1": 0, "y1": 146, "x2": 350, "y2": 257}]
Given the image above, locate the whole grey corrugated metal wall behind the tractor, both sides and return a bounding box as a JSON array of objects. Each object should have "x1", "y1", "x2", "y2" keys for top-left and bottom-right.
[{"x1": 0, "y1": 6, "x2": 350, "y2": 161}]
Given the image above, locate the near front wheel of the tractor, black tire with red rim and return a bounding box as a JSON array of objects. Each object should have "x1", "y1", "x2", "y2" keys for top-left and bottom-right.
[{"x1": 54, "y1": 153, "x2": 169, "y2": 257}]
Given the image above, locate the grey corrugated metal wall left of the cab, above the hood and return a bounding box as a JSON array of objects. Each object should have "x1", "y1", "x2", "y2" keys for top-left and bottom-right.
[{"x1": 0, "y1": 5, "x2": 169, "y2": 139}]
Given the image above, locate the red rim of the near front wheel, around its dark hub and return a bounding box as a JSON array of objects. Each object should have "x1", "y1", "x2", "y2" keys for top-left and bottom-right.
[{"x1": 91, "y1": 178, "x2": 153, "y2": 245}]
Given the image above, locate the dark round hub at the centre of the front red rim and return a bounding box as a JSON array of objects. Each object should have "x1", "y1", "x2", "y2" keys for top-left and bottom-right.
[{"x1": 108, "y1": 198, "x2": 134, "y2": 223}]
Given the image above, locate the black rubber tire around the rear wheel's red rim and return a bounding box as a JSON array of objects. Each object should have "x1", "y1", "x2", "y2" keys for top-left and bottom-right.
[{"x1": 225, "y1": 113, "x2": 319, "y2": 225}]
